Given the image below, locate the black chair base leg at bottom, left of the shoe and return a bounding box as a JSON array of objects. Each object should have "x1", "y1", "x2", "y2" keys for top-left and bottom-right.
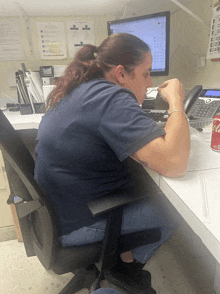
[{"x1": 59, "y1": 265, "x2": 99, "y2": 294}]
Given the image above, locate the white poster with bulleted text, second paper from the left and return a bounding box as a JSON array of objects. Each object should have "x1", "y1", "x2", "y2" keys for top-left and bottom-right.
[{"x1": 37, "y1": 22, "x2": 66, "y2": 59}]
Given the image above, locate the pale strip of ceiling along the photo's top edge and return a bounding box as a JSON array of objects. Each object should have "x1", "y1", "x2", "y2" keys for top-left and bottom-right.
[{"x1": 0, "y1": 0, "x2": 203, "y2": 18}]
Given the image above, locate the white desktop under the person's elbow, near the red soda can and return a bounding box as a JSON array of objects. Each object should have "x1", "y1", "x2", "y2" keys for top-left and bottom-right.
[{"x1": 146, "y1": 129, "x2": 220, "y2": 294}]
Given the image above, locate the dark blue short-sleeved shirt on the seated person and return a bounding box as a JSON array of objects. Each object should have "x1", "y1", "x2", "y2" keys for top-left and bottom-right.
[{"x1": 35, "y1": 79, "x2": 165, "y2": 235}]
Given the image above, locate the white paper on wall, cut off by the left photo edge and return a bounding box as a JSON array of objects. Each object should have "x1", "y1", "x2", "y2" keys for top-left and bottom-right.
[{"x1": 0, "y1": 20, "x2": 25, "y2": 61}]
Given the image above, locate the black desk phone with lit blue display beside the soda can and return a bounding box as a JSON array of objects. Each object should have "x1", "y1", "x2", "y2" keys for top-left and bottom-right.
[{"x1": 184, "y1": 85, "x2": 220, "y2": 119}]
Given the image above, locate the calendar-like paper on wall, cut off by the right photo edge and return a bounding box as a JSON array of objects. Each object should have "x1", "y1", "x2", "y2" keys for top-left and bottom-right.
[{"x1": 207, "y1": 6, "x2": 220, "y2": 59}]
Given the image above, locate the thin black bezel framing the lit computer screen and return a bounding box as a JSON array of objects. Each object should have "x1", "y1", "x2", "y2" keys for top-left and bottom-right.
[{"x1": 107, "y1": 11, "x2": 170, "y2": 76}]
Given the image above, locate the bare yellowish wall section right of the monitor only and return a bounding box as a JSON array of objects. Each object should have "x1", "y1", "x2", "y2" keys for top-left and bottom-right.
[{"x1": 152, "y1": 0, "x2": 220, "y2": 92}]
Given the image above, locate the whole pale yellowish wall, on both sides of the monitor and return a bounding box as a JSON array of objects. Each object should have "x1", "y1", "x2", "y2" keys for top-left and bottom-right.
[{"x1": 0, "y1": 0, "x2": 220, "y2": 101}]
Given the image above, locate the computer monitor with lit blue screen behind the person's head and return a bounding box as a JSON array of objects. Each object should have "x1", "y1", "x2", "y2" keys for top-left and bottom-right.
[{"x1": 107, "y1": 11, "x2": 170, "y2": 76}]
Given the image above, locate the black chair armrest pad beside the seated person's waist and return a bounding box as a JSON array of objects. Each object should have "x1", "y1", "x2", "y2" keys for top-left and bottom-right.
[{"x1": 88, "y1": 192, "x2": 144, "y2": 217}]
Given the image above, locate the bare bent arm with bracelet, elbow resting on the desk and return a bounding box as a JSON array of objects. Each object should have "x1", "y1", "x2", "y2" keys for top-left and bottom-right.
[{"x1": 131, "y1": 79, "x2": 190, "y2": 177}]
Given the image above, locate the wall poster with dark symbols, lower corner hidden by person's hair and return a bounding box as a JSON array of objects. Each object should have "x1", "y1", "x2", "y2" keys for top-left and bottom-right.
[{"x1": 67, "y1": 20, "x2": 95, "y2": 58}]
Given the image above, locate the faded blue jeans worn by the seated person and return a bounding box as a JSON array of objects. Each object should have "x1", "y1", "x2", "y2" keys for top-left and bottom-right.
[{"x1": 60, "y1": 192, "x2": 178, "y2": 264}]
